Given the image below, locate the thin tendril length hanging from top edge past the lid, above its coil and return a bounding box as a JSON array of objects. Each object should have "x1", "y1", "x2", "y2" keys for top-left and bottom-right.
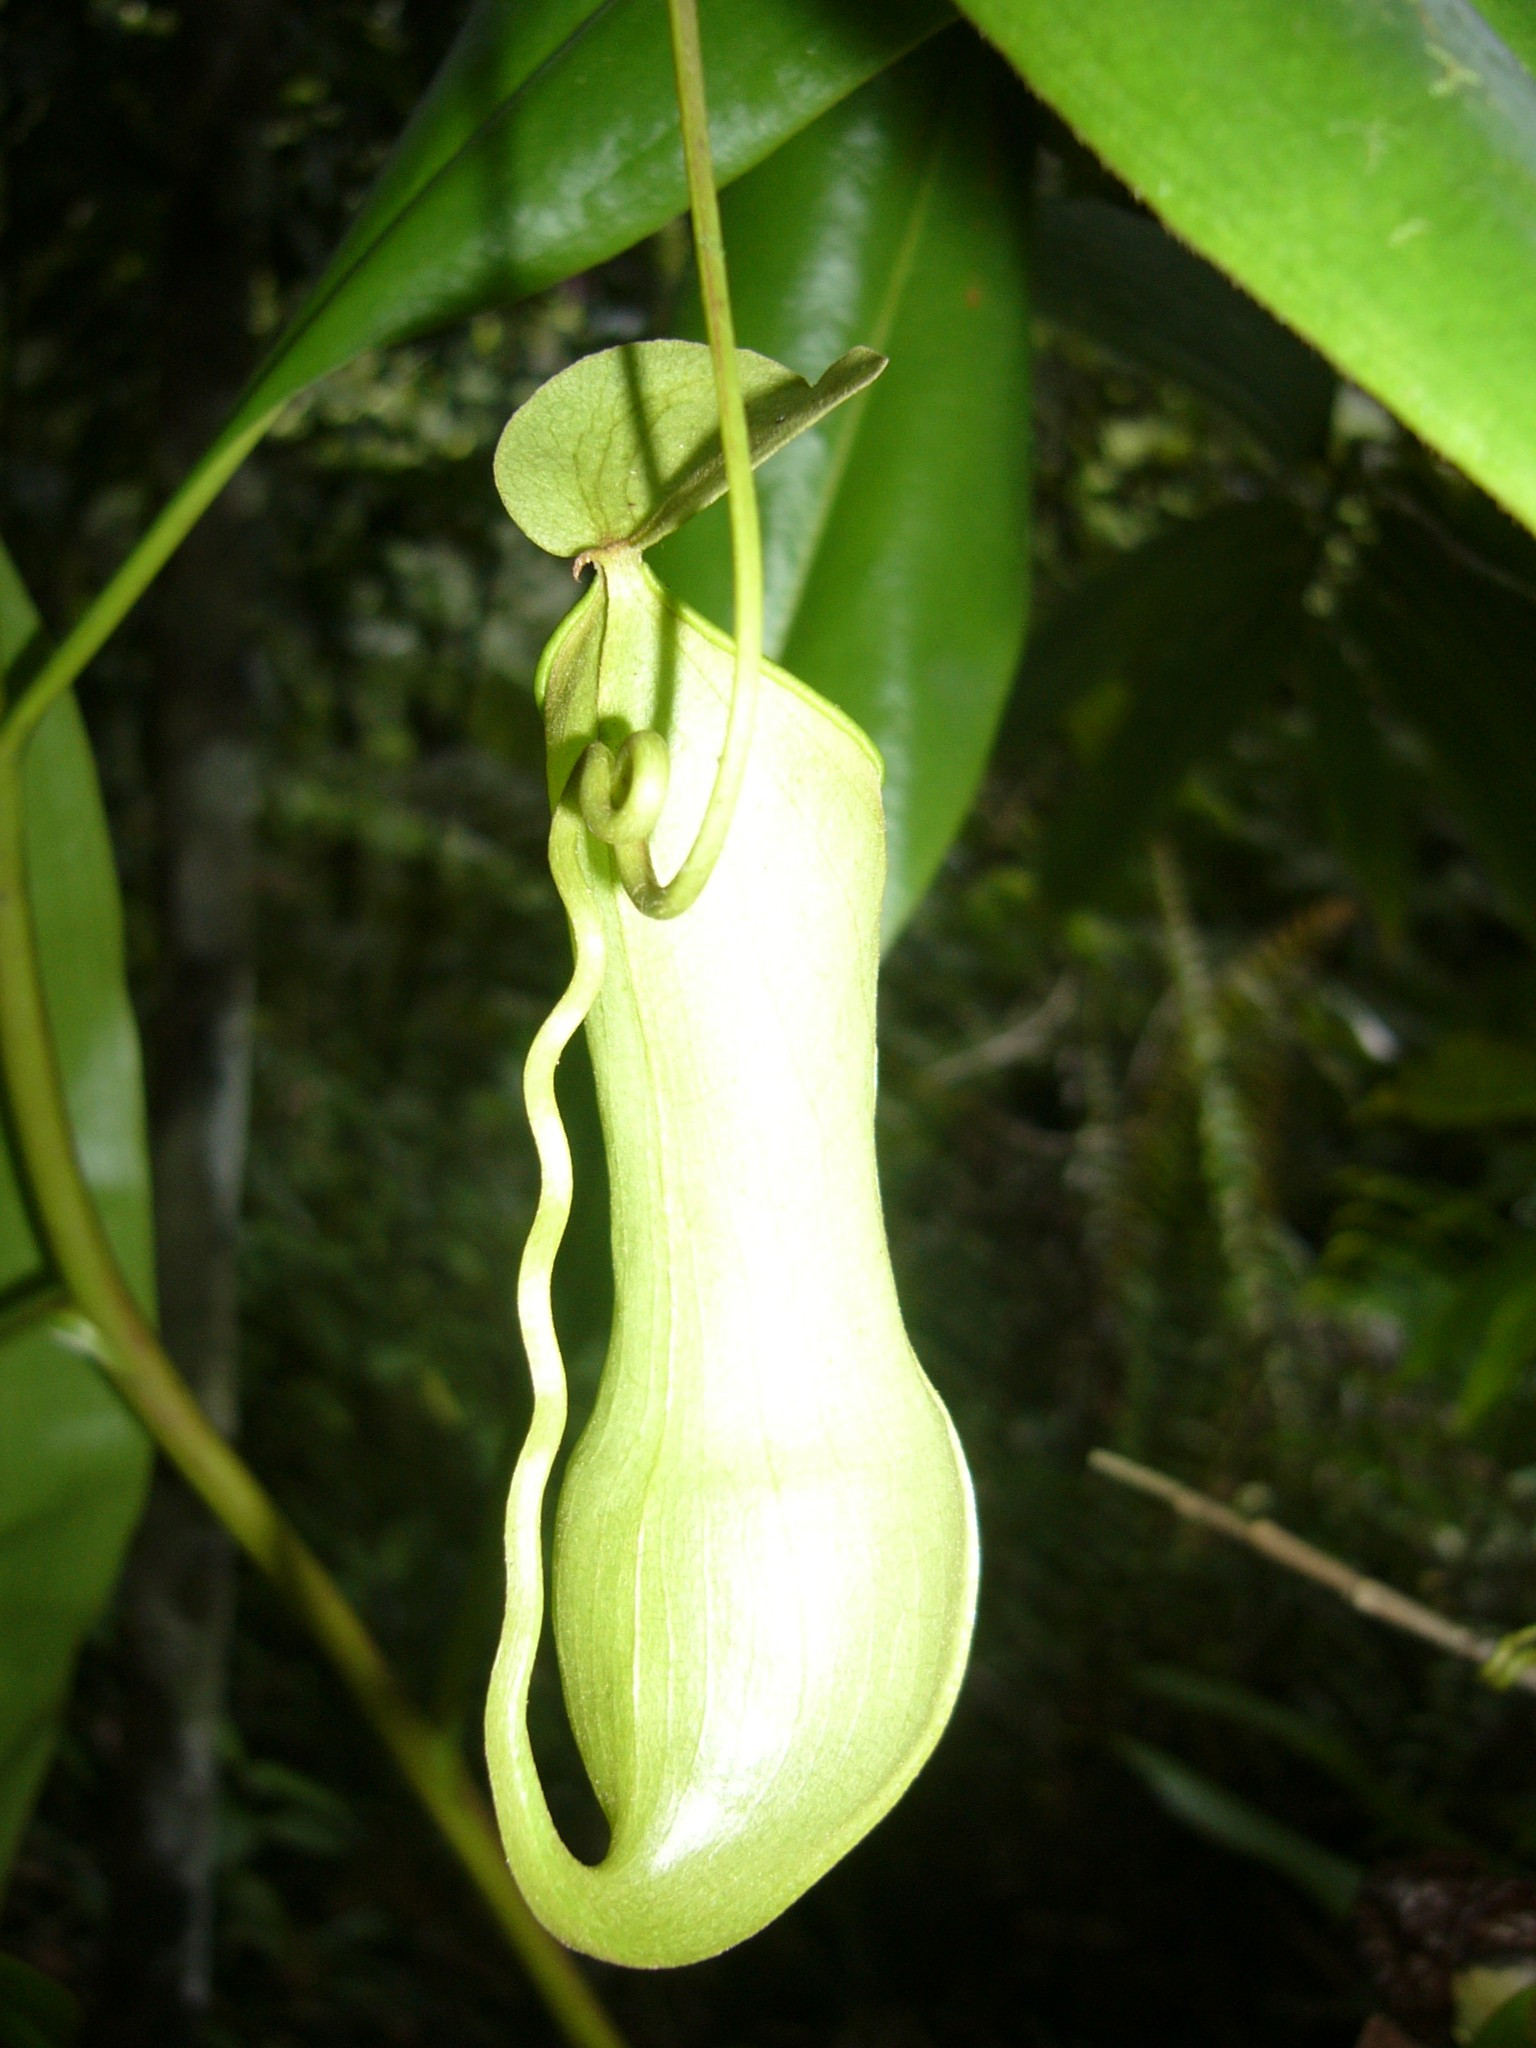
[{"x1": 662, "y1": 0, "x2": 762, "y2": 918}]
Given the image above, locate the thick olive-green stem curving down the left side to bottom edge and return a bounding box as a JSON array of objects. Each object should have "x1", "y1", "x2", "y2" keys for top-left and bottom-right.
[{"x1": 0, "y1": 761, "x2": 623, "y2": 2048}]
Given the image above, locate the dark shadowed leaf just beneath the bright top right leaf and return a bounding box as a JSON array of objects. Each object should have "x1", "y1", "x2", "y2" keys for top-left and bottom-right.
[{"x1": 1034, "y1": 199, "x2": 1333, "y2": 459}]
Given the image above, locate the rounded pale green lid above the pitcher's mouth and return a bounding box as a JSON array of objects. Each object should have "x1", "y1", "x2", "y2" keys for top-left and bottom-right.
[{"x1": 496, "y1": 342, "x2": 885, "y2": 557}]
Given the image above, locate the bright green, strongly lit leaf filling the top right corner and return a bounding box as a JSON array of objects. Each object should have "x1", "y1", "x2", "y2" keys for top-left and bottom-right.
[{"x1": 965, "y1": 0, "x2": 1536, "y2": 524}]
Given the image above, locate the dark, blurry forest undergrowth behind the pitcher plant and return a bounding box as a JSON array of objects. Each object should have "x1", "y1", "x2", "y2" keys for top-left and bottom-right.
[{"x1": 15, "y1": 0, "x2": 1536, "y2": 2048}]
